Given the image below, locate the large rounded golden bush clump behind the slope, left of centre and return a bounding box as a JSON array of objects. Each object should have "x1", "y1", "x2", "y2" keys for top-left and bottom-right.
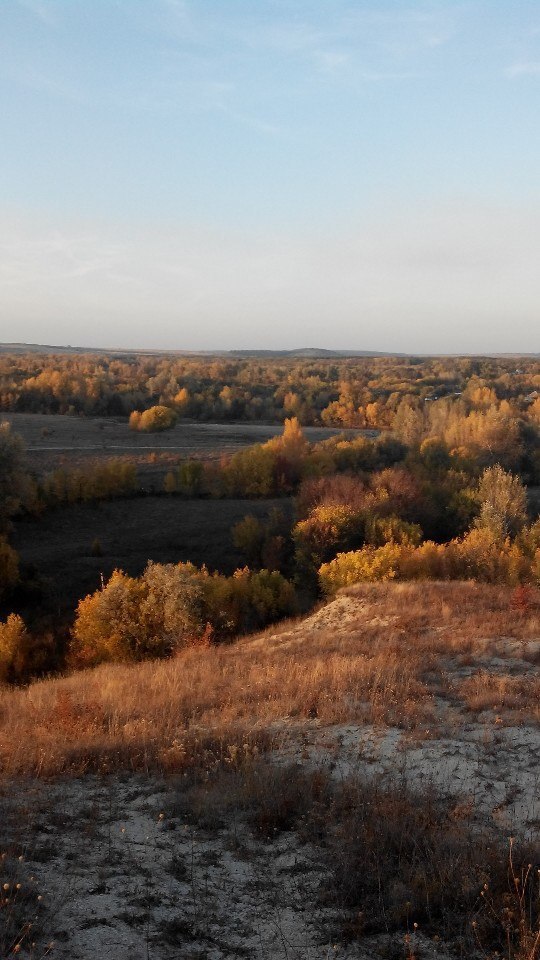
[{"x1": 72, "y1": 563, "x2": 296, "y2": 665}]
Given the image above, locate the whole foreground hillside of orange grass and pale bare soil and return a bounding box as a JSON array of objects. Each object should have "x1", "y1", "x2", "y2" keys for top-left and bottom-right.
[{"x1": 0, "y1": 583, "x2": 540, "y2": 960}]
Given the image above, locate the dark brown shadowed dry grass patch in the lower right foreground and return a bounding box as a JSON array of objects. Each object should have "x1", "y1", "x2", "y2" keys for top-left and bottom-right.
[{"x1": 163, "y1": 758, "x2": 540, "y2": 960}]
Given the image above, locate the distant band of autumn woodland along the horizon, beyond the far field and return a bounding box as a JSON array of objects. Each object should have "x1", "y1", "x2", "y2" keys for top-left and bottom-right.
[{"x1": 0, "y1": 353, "x2": 540, "y2": 430}]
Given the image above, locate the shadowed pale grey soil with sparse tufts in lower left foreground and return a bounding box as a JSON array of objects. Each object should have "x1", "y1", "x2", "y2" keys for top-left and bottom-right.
[{"x1": 3, "y1": 776, "x2": 456, "y2": 960}]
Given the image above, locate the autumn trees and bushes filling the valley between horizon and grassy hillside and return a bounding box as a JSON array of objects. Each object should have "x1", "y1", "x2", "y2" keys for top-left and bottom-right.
[{"x1": 0, "y1": 353, "x2": 540, "y2": 683}]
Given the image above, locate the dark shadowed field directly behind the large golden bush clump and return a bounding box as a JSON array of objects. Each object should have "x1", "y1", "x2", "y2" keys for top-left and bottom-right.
[{"x1": 12, "y1": 496, "x2": 293, "y2": 611}]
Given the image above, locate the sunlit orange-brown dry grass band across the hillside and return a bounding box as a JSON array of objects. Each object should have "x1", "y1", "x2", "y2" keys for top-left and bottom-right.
[{"x1": 0, "y1": 583, "x2": 538, "y2": 776}]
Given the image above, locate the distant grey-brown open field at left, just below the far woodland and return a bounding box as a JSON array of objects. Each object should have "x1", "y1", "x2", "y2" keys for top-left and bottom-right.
[{"x1": 0, "y1": 413, "x2": 377, "y2": 474}]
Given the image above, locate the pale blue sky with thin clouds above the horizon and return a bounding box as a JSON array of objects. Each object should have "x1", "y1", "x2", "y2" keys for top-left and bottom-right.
[{"x1": 0, "y1": 0, "x2": 540, "y2": 353}]
